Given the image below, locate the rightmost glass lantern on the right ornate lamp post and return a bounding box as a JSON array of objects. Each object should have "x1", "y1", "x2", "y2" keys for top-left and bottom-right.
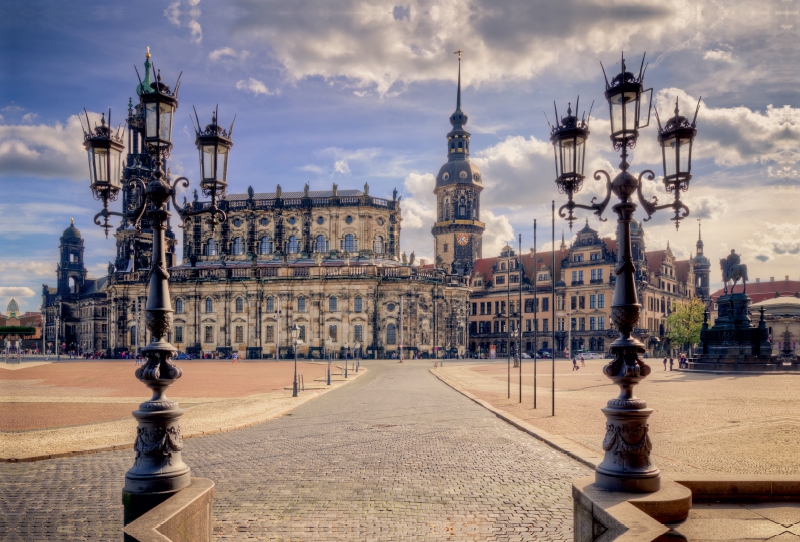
[{"x1": 656, "y1": 100, "x2": 700, "y2": 192}]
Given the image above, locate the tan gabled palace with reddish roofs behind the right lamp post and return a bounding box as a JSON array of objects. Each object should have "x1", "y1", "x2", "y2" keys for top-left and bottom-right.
[{"x1": 470, "y1": 221, "x2": 708, "y2": 360}]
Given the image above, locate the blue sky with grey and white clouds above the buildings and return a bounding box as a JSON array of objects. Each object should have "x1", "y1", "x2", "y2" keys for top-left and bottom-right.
[{"x1": 0, "y1": 0, "x2": 800, "y2": 311}]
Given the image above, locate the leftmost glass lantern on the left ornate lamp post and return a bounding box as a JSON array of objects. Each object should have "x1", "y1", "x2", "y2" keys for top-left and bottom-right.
[{"x1": 83, "y1": 112, "x2": 125, "y2": 200}]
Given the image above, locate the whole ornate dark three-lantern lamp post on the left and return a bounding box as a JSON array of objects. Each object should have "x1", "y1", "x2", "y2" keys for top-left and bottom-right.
[{"x1": 84, "y1": 47, "x2": 232, "y2": 524}]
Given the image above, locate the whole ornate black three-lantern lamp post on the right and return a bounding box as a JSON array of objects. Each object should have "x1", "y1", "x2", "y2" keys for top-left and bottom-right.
[{"x1": 550, "y1": 53, "x2": 700, "y2": 492}]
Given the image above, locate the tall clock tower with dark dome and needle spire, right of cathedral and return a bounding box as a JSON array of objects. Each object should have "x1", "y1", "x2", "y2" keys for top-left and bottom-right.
[{"x1": 431, "y1": 50, "x2": 486, "y2": 274}]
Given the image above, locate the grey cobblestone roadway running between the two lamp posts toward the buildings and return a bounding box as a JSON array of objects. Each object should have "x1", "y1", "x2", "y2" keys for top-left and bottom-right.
[{"x1": 0, "y1": 362, "x2": 590, "y2": 541}]
